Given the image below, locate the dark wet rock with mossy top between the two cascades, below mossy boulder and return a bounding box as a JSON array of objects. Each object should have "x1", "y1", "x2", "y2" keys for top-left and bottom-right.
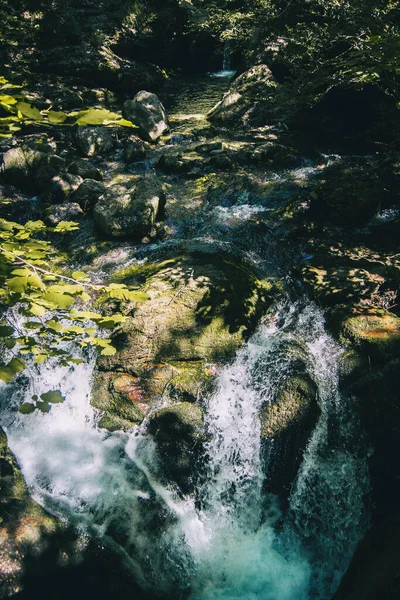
[{"x1": 147, "y1": 402, "x2": 206, "y2": 494}]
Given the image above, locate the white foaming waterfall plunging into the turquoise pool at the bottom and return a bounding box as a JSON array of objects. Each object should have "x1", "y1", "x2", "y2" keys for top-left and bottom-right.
[{"x1": 0, "y1": 300, "x2": 368, "y2": 600}]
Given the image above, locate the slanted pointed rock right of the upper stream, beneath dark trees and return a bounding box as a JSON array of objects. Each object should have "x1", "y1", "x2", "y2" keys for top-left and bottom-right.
[{"x1": 208, "y1": 65, "x2": 277, "y2": 125}]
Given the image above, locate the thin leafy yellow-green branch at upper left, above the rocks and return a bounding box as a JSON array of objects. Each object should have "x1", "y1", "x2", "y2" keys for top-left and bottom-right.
[{"x1": 0, "y1": 77, "x2": 135, "y2": 137}]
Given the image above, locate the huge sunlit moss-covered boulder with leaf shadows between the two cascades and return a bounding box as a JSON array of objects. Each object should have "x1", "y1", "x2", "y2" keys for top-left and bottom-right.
[{"x1": 92, "y1": 252, "x2": 273, "y2": 432}]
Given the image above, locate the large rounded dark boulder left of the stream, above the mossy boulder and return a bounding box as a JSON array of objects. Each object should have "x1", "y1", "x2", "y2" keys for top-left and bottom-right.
[{"x1": 93, "y1": 177, "x2": 165, "y2": 239}]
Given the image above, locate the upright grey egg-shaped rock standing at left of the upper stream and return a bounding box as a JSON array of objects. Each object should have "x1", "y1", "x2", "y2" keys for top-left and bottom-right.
[{"x1": 123, "y1": 91, "x2": 169, "y2": 142}]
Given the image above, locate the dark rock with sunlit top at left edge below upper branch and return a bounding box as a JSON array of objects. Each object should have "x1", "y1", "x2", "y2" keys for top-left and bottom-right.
[{"x1": 0, "y1": 147, "x2": 65, "y2": 191}]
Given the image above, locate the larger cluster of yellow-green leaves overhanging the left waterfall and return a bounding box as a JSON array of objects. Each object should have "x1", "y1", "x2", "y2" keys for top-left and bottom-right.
[{"x1": 0, "y1": 219, "x2": 147, "y2": 390}]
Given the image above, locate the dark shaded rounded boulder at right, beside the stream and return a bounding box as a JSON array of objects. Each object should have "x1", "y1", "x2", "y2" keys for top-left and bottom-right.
[{"x1": 310, "y1": 164, "x2": 382, "y2": 226}]
